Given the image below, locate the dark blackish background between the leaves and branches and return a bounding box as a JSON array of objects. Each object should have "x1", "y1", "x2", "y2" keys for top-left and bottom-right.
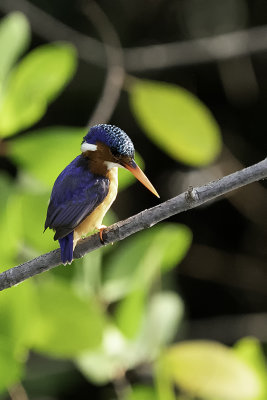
[{"x1": 0, "y1": 0, "x2": 267, "y2": 399}]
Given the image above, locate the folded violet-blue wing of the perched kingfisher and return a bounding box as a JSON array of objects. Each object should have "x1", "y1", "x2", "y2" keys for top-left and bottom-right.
[{"x1": 45, "y1": 156, "x2": 109, "y2": 240}]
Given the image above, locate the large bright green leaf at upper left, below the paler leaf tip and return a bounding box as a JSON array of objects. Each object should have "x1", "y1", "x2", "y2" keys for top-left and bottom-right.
[{"x1": 0, "y1": 43, "x2": 76, "y2": 137}]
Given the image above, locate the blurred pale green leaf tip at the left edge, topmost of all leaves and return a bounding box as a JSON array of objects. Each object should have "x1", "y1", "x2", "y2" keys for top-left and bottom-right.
[{"x1": 0, "y1": 12, "x2": 30, "y2": 89}]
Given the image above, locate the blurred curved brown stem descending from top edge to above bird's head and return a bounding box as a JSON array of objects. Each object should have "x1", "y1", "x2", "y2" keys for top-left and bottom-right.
[{"x1": 85, "y1": 0, "x2": 125, "y2": 127}]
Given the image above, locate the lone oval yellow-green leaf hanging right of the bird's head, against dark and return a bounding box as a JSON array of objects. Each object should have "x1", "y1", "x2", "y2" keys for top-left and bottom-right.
[{"x1": 130, "y1": 80, "x2": 222, "y2": 166}]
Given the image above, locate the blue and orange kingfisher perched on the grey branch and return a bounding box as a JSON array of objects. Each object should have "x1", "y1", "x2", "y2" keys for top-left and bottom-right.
[{"x1": 44, "y1": 124, "x2": 159, "y2": 265}]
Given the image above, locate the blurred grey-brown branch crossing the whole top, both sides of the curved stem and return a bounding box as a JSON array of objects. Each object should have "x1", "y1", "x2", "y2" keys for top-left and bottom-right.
[{"x1": 0, "y1": 0, "x2": 267, "y2": 72}]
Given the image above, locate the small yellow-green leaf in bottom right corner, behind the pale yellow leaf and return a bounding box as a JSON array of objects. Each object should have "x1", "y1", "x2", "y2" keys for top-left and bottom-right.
[{"x1": 234, "y1": 337, "x2": 267, "y2": 400}]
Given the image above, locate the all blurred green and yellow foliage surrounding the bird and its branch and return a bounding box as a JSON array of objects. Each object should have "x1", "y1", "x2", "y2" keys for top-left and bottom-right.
[{"x1": 0, "y1": 13, "x2": 267, "y2": 400}]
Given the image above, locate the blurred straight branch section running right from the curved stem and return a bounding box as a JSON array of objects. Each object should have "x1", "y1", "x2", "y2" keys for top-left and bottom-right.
[{"x1": 124, "y1": 25, "x2": 267, "y2": 71}]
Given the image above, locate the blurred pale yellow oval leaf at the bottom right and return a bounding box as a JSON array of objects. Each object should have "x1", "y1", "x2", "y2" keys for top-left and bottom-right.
[{"x1": 163, "y1": 341, "x2": 261, "y2": 400}]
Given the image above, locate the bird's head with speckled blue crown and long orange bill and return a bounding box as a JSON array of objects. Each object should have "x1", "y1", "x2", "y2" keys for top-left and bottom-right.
[{"x1": 81, "y1": 124, "x2": 159, "y2": 197}]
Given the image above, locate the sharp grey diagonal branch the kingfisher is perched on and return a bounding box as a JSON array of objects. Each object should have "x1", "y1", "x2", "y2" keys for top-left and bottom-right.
[{"x1": 0, "y1": 158, "x2": 267, "y2": 290}]
